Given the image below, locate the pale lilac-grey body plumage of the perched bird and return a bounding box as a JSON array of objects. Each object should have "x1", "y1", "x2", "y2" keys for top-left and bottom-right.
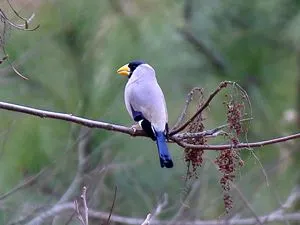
[{"x1": 124, "y1": 64, "x2": 168, "y2": 131}]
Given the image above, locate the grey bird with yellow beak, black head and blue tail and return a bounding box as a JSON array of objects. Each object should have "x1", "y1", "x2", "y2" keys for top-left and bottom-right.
[{"x1": 117, "y1": 60, "x2": 174, "y2": 168}]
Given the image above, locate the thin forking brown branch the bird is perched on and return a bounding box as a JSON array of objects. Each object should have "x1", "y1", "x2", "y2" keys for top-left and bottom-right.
[{"x1": 0, "y1": 100, "x2": 300, "y2": 151}]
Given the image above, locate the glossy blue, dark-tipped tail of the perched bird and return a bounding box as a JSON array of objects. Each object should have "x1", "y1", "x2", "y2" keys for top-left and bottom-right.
[{"x1": 156, "y1": 132, "x2": 173, "y2": 168}]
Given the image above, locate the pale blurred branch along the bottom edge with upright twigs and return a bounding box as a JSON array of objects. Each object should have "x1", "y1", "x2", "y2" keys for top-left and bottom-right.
[{"x1": 22, "y1": 186, "x2": 300, "y2": 225}]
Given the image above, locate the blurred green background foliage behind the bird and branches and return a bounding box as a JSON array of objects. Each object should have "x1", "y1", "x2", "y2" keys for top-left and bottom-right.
[{"x1": 0, "y1": 0, "x2": 300, "y2": 224}]
